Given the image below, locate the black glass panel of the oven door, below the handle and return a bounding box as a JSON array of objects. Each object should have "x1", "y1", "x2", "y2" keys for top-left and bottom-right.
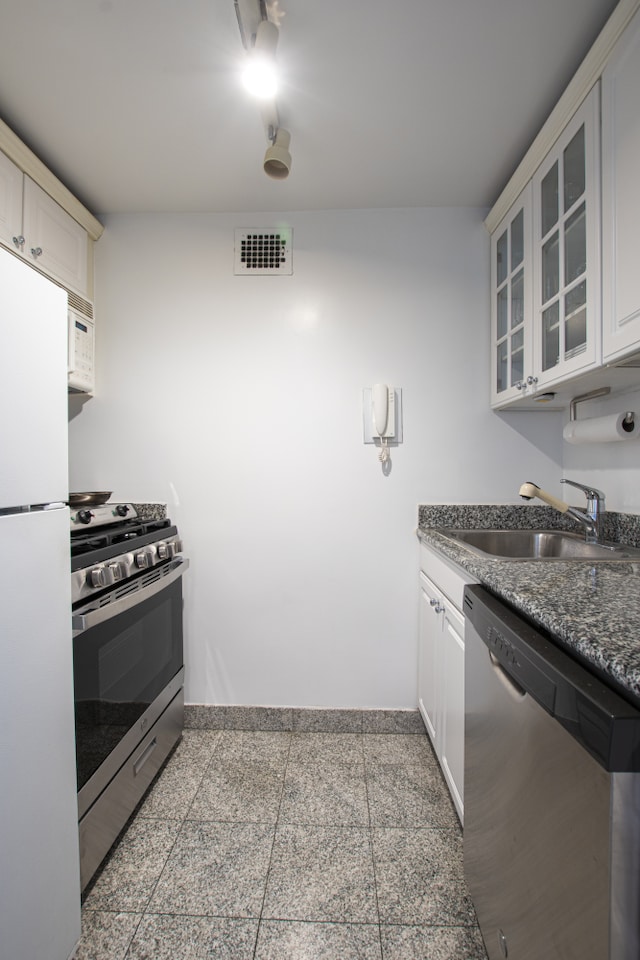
[{"x1": 73, "y1": 578, "x2": 183, "y2": 790}]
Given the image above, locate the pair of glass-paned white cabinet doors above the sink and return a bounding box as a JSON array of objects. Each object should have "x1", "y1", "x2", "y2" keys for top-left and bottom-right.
[{"x1": 491, "y1": 84, "x2": 602, "y2": 408}]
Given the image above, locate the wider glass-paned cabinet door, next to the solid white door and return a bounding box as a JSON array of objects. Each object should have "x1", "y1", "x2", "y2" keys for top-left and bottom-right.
[{"x1": 533, "y1": 85, "x2": 601, "y2": 389}]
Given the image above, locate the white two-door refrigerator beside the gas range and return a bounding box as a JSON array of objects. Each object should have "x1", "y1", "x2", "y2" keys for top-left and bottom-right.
[{"x1": 0, "y1": 248, "x2": 80, "y2": 960}]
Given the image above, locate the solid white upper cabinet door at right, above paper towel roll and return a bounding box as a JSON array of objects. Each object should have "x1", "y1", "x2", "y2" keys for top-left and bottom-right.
[{"x1": 602, "y1": 7, "x2": 640, "y2": 362}]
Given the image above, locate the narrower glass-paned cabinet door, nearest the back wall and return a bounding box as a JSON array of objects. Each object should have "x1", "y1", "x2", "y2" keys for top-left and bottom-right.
[{"x1": 491, "y1": 184, "x2": 533, "y2": 406}]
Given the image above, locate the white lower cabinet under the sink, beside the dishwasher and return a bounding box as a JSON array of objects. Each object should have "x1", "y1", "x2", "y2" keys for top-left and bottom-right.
[{"x1": 418, "y1": 544, "x2": 475, "y2": 822}]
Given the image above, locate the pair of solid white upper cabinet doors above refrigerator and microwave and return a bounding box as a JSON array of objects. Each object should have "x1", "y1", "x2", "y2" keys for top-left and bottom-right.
[{"x1": 0, "y1": 153, "x2": 90, "y2": 297}]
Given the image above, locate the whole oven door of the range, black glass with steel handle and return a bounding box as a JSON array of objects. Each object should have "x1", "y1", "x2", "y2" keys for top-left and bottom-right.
[{"x1": 73, "y1": 558, "x2": 189, "y2": 817}]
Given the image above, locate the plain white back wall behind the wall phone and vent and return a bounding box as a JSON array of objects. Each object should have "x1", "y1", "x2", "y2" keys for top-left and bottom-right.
[{"x1": 70, "y1": 208, "x2": 562, "y2": 708}]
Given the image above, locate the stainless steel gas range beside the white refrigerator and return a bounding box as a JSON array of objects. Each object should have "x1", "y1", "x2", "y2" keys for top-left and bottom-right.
[{"x1": 71, "y1": 503, "x2": 189, "y2": 889}]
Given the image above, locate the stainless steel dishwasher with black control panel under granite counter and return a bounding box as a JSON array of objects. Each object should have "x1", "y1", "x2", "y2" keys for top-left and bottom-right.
[{"x1": 464, "y1": 586, "x2": 640, "y2": 960}]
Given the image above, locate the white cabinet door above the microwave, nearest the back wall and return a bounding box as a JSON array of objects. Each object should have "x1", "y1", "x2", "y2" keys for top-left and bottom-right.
[{"x1": 23, "y1": 177, "x2": 88, "y2": 297}]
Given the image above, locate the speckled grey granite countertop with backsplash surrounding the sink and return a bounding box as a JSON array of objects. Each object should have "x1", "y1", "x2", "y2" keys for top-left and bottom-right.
[{"x1": 418, "y1": 504, "x2": 640, "y2": 706}]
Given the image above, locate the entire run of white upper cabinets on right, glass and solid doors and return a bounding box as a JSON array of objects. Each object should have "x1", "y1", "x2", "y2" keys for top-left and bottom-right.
[{"x1": 485, "y1": 0, "x2": 640, "y2": 410}]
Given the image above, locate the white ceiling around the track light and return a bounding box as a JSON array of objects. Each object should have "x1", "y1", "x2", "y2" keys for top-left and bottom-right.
[{"x1": 0, "y1": 0, "x2": 615, "y2": 215}]
